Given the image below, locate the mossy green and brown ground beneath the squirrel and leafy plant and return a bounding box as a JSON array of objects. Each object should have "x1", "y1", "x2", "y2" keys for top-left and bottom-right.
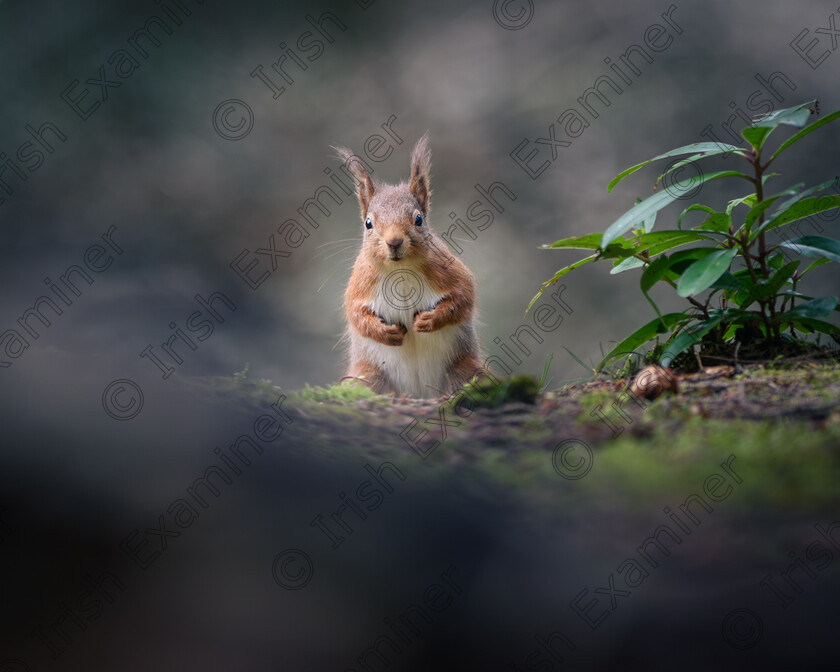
[{"x1": 194, "y1": 361, "x2": 840, "y2": 510}]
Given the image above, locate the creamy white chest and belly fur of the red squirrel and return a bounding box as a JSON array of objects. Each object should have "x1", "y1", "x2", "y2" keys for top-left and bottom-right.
[{"x1": 359, "y1": 265, "x2": 460, "y2": 397}]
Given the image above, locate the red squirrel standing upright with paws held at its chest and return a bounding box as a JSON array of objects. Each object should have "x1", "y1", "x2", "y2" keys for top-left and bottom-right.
[{"x1": 336, "y1": 134, "x2": 482, "y2": 397}]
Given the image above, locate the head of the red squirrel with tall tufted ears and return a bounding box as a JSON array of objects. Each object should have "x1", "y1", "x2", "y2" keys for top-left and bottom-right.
[{"x1": 336, "y1": 133, "x2": 432, "y2": 265}]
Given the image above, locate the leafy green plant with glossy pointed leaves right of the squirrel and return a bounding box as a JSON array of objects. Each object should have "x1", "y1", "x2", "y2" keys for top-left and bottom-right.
[{"x1": 528, "y1": 101, "x2": 840, "y2": 371}]
